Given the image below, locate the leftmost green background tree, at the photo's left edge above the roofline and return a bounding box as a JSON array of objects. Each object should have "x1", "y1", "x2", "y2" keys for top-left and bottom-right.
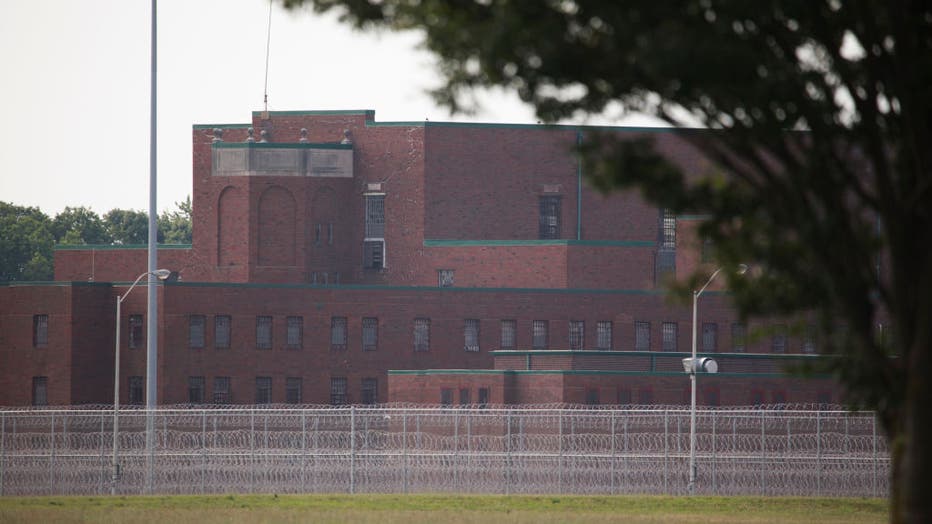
[{"x1": 0, "y1": 202, "x2": 55, "y2": 281}]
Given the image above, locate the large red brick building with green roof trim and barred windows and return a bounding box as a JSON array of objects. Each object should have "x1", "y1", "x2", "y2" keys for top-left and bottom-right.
[{"x1": 0, "y1": 111, "x2": 838, "y2": 405}]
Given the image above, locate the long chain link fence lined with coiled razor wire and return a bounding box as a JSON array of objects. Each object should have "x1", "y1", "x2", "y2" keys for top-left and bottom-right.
[{"x1": 0, "y1": 406, "x2": 890, "y2": 497}]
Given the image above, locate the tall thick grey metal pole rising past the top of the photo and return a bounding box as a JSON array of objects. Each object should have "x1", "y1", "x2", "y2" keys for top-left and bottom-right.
[{"x1": 146, "y1": 0, "x2": 159, "y2": 490}]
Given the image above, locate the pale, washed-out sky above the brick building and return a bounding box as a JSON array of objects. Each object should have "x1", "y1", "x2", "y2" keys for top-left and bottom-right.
[{"x1": 0, "y1": 0, "x2": 649, "y2": 216}]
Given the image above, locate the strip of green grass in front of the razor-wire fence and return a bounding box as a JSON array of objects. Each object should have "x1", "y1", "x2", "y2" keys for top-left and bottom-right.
[{"x1": 0, "y1": 495, "x2": 887, "y2": 524}]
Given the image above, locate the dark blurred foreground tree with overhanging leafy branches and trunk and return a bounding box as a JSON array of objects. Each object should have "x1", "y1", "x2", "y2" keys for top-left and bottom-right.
[{"x1": 284, "y1": 0, "x2": 932, "y2": 522}]
